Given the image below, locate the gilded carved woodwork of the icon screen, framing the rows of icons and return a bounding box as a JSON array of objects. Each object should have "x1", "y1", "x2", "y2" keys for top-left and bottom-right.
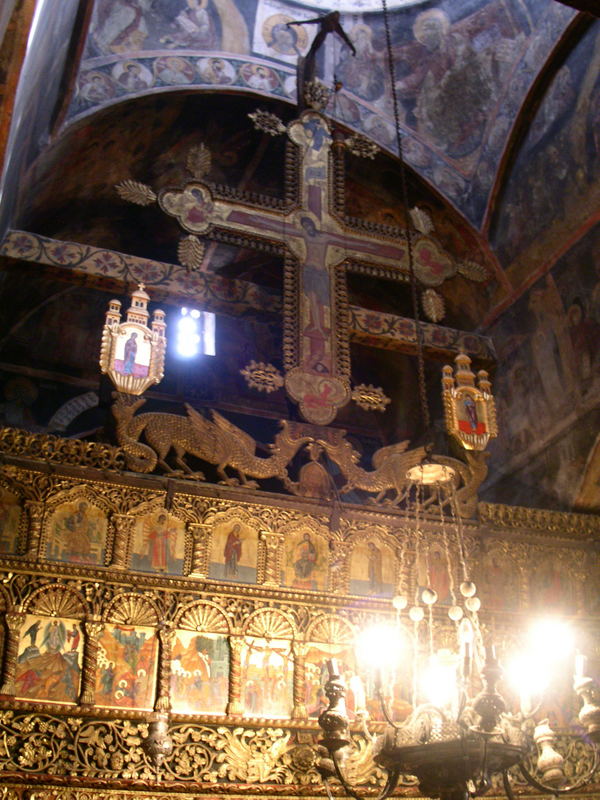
[{"x1": 0, "y1": 456, "x2": 598, "y2": 800}]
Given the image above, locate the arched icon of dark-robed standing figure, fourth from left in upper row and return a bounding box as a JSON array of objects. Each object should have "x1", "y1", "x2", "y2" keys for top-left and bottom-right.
[{"x1": 208, "y1": 519, "x2": 258, "y2": 583}]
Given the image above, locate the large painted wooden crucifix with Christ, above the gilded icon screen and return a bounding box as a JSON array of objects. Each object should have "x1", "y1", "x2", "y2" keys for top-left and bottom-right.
[{"x1": 118, "y1": 109, "x2": 464, "y2": 425}]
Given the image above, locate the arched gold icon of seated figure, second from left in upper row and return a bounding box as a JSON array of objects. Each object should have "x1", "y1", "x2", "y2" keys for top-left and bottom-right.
[{"x1": 46, "y1": 498, "x2": 108, "y2": 564}]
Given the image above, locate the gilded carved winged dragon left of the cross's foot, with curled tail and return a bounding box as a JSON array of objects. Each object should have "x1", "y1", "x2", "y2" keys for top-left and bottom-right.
[{"x1": 112, "y1": 394, "x2": 309, "y2": 488}]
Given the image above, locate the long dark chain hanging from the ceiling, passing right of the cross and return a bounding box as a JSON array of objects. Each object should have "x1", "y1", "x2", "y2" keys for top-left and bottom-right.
[{"x1": 381, "y1": 0, "x2": 430, "y2": 430}]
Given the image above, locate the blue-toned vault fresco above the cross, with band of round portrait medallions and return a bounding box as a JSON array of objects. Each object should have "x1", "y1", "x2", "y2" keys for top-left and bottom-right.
[{"x1": 68, "y1": 0, "x2": 575, "y2": 223}]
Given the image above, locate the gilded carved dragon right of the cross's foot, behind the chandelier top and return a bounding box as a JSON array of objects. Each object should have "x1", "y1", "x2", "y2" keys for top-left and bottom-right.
[{"x1": 319, "y1": 440, "x2": 427, "y2": 504}]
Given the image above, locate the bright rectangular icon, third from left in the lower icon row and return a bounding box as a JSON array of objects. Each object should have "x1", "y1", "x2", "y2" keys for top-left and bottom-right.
[{"x1": 171, "y1": 631, "x2": 229, "y2": 714}]
